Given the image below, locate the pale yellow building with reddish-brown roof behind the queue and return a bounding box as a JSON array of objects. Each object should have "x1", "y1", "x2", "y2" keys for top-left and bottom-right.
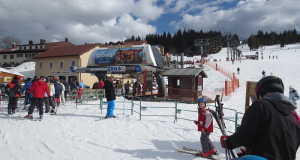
[{"x1": 33, "y1": 43, "x2": 102, "y2": 88}]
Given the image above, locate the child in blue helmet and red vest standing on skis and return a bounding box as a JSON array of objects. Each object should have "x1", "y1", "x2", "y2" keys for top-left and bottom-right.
[{"x1": 194, "y1": 98, "x2": 216, "y2": 157}]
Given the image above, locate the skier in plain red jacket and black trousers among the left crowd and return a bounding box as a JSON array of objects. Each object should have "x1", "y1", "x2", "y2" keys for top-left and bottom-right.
[{"x1": 24, "y1": 76, "x2": 51, "y2": 119}]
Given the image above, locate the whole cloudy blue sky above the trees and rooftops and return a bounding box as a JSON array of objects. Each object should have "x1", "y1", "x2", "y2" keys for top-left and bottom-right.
[{"x1": 0, "y1": 0, "x2": 300, "y2": 45}]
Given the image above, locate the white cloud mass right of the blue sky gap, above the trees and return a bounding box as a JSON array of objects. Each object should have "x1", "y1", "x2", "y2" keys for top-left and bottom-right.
[{"x1": 173, "y1": 0, "x2": 300, "y2": 38}]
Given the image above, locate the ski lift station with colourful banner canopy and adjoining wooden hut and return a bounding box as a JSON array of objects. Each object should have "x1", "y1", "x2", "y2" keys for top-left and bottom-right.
[{"x1": 70, "y1": 44, "x2": 207, "y2": 101}]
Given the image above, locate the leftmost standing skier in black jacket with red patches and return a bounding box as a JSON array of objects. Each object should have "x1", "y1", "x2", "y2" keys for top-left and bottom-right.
[{"x1": 5, "y1": 75, "x2": 22, "y2": 115}]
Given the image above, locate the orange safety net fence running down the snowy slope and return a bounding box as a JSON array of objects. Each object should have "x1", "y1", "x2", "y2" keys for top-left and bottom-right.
[{"x1": 203, "y1": 60, "x2": 240, "y2": 96}]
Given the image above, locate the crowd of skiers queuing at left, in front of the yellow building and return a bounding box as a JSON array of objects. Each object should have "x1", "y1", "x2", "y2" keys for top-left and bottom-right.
[{"x1": 5, "y1": 76, "x2": 83, "y2": 118}]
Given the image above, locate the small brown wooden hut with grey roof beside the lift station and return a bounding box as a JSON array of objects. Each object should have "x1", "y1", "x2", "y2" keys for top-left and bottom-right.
[{"x1": 162, "y1": 68, "x2": 208, "y2": 102}]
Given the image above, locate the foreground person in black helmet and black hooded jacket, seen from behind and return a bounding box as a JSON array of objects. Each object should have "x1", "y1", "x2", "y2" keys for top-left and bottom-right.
[{"x1": 220, "y1": 76, "x2": 300, "y2": 160}]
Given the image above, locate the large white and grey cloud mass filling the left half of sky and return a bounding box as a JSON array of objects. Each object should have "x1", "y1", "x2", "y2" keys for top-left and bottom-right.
[{"x1": 0, "y1": 0, "x2": 164, "y2": 44}]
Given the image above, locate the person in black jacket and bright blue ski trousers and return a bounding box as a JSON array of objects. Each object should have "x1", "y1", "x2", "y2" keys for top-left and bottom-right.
[{"x1": 104, "y1": 76, "x2": 116, "y2": 118}]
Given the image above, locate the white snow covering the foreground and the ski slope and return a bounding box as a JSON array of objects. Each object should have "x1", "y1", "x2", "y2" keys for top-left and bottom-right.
[{"x1": 0, "y1": 44, "x2": 300, "y2": 160}]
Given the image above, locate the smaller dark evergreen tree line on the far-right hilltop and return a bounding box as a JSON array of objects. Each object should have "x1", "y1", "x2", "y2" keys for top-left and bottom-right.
[{"x1": 248, "y1": 29, "x2": 300, "y2": 50}]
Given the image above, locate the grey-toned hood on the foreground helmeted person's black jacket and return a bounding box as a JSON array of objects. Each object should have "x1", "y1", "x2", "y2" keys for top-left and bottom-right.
[{"x1": 263, "y1": 93, "x2": 297, "y2": 113}]
